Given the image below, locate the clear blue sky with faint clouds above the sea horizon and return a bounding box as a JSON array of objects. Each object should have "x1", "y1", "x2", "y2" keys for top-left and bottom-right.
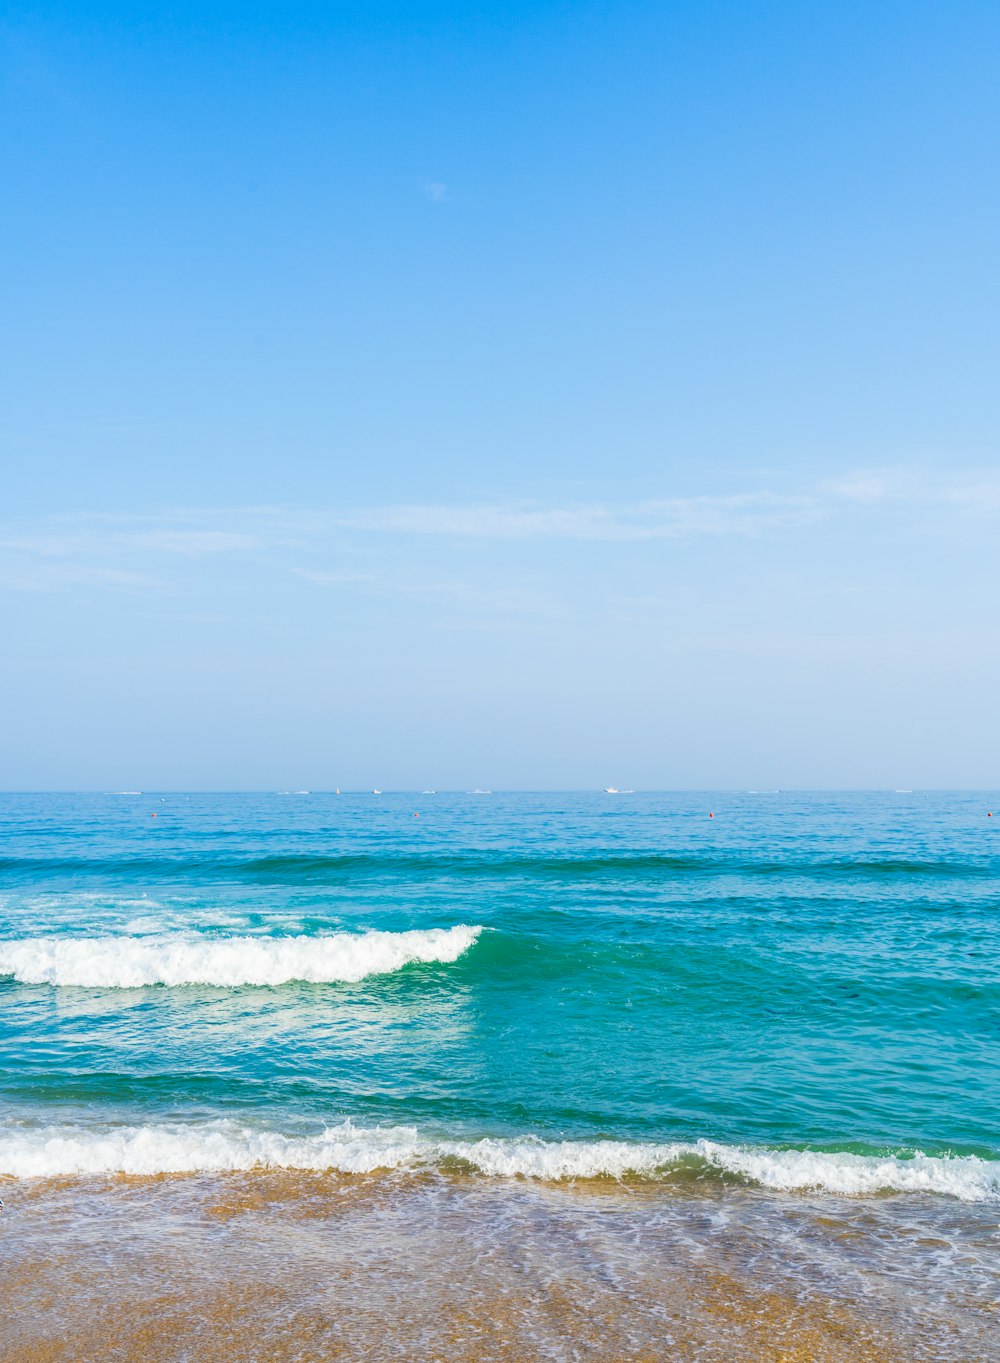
[{"x1": 0, "y1": 0, "x2": 1000, "y2": 789}]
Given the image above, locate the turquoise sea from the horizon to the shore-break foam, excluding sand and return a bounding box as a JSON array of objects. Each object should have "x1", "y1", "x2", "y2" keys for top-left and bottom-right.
[{"x1": 0, "y1": 793, "x2": 1000, "y2": 1201}]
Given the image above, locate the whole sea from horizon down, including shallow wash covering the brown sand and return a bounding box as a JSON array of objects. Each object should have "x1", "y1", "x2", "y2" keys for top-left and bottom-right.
[{"x1": 0, "y1": 791, "x2": 1000, "y2": 1360}]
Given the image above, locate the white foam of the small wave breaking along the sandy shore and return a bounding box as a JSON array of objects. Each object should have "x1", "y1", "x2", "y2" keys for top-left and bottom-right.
[{"x1": 0, "y1": 1120, "x2": 1000, "y2": 1202}]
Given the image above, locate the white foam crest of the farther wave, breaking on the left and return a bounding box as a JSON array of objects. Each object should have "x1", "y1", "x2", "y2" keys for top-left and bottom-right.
[{"x1": 0, "y1": 924, "x2": 482, "y2": 990}]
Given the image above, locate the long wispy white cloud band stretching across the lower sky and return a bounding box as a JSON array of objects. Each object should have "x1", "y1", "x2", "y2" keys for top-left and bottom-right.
[{"x1": 0, "y1": 469, "x2": 1000, "y2": 596}]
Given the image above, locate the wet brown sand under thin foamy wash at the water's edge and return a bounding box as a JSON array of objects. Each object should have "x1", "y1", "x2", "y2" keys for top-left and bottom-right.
[{"x1": 0, "y1": 1172, "x2": 1000, "y2": 1363}]
